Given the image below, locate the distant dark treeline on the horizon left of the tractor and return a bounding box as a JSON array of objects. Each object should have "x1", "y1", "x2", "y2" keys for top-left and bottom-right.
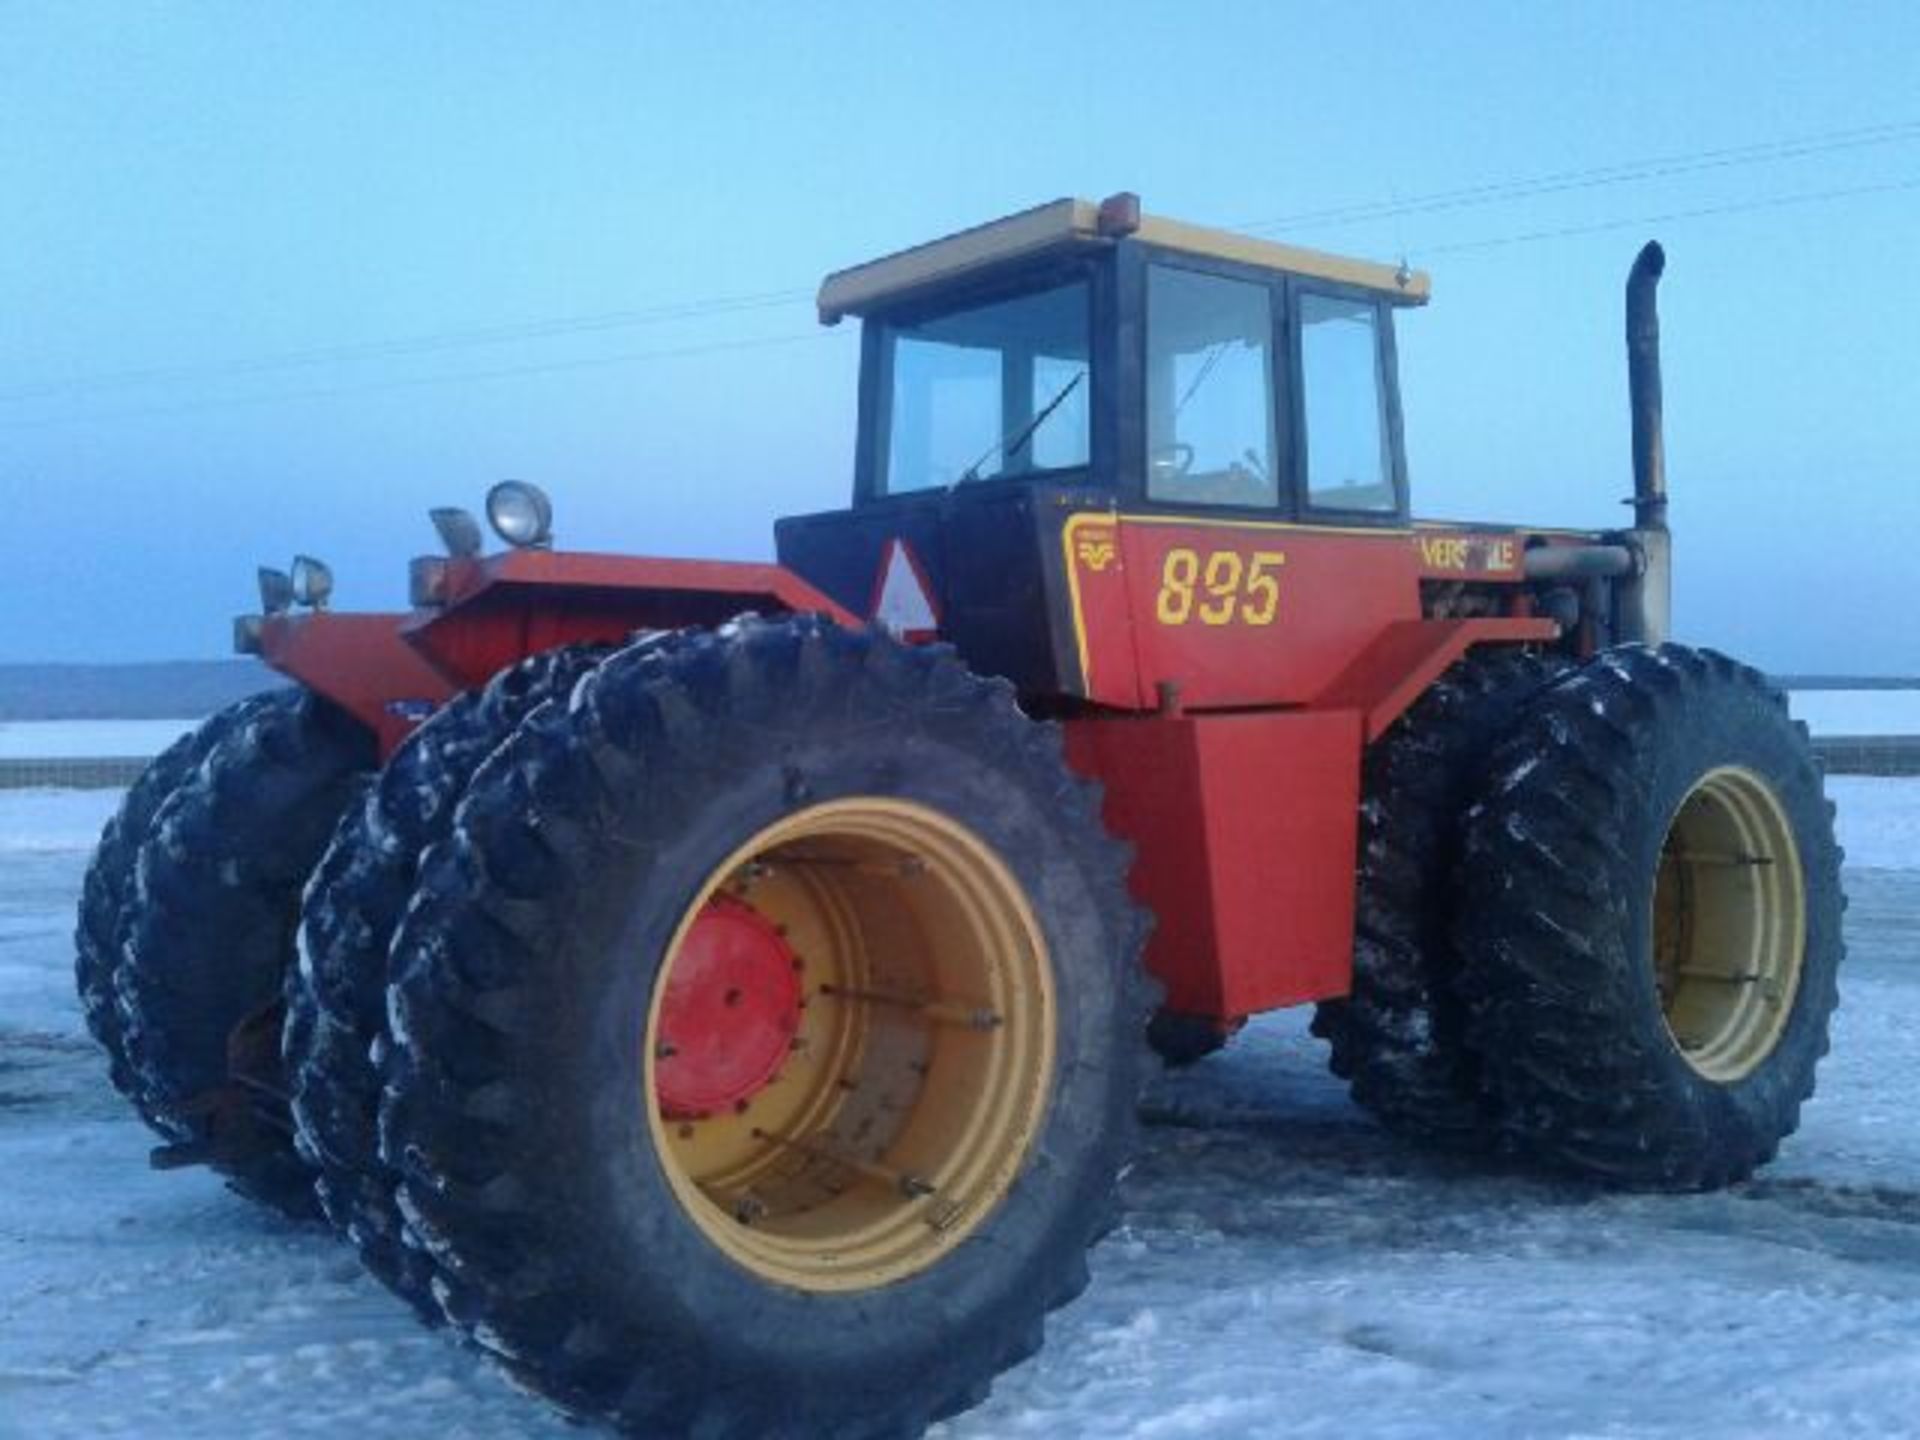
[{"x1": 0, "y1": 660, "x2": 286, "y2": 720}]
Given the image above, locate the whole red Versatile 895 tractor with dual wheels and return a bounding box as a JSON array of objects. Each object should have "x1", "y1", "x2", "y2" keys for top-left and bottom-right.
[{"x1": 79, "y1": 194, "x2": 1843, "y2": 1436}]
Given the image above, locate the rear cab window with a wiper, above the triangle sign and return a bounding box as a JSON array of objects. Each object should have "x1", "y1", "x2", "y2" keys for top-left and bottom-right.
[{"x1": 881, "y1": 280, "x2": 1091, "y2": 495}]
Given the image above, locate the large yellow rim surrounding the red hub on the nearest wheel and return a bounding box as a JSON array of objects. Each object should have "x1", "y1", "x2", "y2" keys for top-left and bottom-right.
[{"x1": 643, "y1": 799, "x2": 1054, "y2": 1292}]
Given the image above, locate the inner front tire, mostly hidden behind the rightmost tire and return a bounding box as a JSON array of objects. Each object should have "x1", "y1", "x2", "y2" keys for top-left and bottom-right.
[{"x1": 1313, "y1": 649, "x2": 1565, "y2": 1150}]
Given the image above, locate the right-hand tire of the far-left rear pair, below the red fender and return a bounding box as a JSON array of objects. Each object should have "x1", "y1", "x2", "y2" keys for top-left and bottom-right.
[{"x1": 113, "y1": 689, "x2": 374, "y2": 1215}]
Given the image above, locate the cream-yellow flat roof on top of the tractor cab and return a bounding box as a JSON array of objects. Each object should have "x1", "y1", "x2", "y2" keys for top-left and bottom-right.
[{"x1": 820, "y1": 194, "x2": 1432, "y2": 324}]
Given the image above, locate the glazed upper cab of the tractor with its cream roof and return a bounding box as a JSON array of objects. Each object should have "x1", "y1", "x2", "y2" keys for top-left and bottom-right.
[{"x1": 820, "y1": 196, "x2": 1427, "y2": 524}]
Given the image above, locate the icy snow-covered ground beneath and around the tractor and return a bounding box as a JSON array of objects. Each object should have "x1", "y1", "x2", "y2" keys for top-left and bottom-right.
[{"x1": 11, "y1": 780, "x2": 1920, "y2": 1440}]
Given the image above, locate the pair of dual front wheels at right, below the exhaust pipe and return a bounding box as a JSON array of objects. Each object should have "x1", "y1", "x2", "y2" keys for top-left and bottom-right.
[{"x1": 1315, "y1": 645, "x2": 1845, "y2": 1190}]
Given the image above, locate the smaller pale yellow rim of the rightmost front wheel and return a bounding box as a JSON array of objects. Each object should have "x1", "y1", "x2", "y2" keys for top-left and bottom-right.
[{"x1": 1653, "y1": 766, "x2": 1807, "y2": 1083}]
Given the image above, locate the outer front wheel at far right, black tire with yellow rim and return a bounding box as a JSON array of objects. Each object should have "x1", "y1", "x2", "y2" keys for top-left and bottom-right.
[{"x1": 1457, "y1": 645, "x2": 1845, "y2": 1190}]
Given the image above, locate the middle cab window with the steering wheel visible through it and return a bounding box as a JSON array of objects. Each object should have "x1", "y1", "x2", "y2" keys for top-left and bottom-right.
[{"x1": 1146, "y1": 265, "x2": 1281, "y2": 507}]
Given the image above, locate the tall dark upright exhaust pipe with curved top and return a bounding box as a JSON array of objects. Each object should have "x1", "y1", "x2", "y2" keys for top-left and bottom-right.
[{"x1": 1613, "y1": 240, "x2": 1672, "y2": 645}]
